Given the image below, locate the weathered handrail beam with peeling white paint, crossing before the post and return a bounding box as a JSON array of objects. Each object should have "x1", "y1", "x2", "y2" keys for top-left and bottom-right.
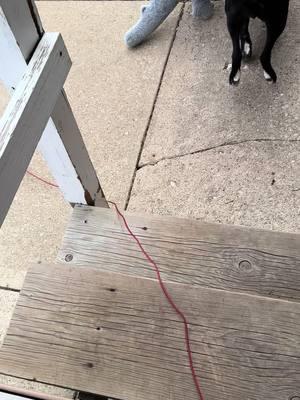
[{"x1": 0, "y1": 33, "x2": 71, "y2": 225}]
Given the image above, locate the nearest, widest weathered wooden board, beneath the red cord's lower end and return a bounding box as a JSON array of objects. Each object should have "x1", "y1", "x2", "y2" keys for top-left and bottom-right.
[{"x1": 0, "y1": 265, "x2": 300, "y2": 400}]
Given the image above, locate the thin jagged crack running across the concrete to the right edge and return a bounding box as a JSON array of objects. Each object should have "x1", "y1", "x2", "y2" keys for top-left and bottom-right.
[{"x1": 137, "y1": 139, "x2": 300, "y2": 171}]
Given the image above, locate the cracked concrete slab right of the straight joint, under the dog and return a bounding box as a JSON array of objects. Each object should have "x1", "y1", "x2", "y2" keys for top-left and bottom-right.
[{"x1": 130, "y1": 0, "x2": 300, "y2": 232}]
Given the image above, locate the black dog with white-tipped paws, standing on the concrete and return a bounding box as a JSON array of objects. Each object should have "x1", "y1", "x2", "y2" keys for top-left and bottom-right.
[{"x1": 225, "y1": 0, "x2": 289, "y2": 85}]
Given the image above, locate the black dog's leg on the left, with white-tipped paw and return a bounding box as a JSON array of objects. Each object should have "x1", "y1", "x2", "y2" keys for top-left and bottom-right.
[{"x1": 227, "y1": 13, "x2": 245, "y2": 85}]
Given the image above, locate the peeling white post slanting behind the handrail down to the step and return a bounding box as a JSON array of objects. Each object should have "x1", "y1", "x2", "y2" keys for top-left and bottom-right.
[{"x1": 0, "y1": 0, "x2": 107, "y2": 207}]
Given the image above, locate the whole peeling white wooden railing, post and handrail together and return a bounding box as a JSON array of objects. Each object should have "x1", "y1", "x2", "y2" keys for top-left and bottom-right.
[{"x1": 0, "y1": 0, "x2": 107, "y2": 226}]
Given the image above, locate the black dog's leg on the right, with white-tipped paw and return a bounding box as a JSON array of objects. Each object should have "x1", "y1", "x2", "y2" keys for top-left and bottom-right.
[{"x1": 260, "y1": 22, "x2": 285, "y2": 83}]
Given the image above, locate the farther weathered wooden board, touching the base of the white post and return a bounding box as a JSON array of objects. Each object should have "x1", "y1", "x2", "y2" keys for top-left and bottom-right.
[{"x1": 58, "y1": 207, "x2": 300, "y2": 300}]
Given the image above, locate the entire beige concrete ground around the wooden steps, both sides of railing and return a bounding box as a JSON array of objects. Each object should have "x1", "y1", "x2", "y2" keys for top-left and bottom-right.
[{"x1": 0, "y1": 0, "x2": 300, "y2": 397}]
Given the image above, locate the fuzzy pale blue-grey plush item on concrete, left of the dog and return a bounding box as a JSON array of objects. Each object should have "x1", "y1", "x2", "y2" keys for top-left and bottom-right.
[{"x1": 125, "y1": 0, "x2": 213, "y2": 47}]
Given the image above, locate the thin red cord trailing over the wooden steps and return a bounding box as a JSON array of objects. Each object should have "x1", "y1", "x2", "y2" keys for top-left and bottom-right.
[{"x1": 27, "y1": 171, "x2": 204, "y2": 400}]
